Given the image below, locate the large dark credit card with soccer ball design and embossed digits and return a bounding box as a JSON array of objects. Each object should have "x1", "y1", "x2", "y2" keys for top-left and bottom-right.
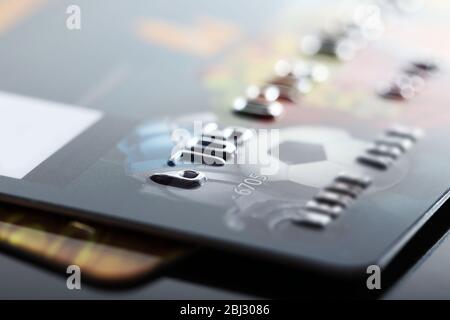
[{"x1": 0, "y1": 0, "x2": 450, "y2": 272}]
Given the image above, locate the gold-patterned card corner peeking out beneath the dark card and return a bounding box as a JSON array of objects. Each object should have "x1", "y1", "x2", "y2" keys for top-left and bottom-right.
[{"x1": 0, "y1": 205, "x2": 189, "y2": 286}]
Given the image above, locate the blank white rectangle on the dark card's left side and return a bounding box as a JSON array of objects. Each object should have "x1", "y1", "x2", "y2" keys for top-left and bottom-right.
[{"x1": 0, "y1": 91, "x2": 102, "y2": 179}]
